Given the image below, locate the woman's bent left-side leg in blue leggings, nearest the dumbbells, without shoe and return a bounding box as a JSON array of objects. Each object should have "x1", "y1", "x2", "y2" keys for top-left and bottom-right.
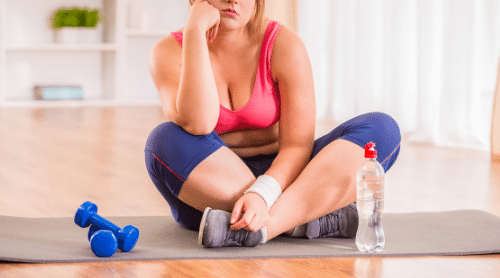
[{"x1": 145, "y1": 122, "x2": 255, "y2": 230}]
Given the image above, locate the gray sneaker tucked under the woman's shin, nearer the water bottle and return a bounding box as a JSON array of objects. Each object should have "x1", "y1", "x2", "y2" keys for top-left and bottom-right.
[{"x1": 306, "y1": 203, "x2": 359, "y2": 239}]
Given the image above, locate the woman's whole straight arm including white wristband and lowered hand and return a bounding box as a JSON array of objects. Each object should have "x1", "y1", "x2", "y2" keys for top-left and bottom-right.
[{"x1": 231, "y1": 27, "x2": 316, "y2": 231}]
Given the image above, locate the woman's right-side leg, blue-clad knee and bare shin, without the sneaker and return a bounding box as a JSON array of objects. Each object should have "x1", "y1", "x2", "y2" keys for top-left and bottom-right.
[{"x1": 267, "y1": 113, "x2": 401, "y2": 239}]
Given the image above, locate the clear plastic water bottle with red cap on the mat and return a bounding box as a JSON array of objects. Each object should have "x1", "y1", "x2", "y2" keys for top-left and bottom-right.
[{"x1": 356, "y1": 142, "x2": 385, "y2": 253}]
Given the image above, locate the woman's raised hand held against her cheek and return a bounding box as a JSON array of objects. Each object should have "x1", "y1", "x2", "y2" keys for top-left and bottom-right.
[{"x1": 186, "y1": 0, "x2": 220, "y2": 42}]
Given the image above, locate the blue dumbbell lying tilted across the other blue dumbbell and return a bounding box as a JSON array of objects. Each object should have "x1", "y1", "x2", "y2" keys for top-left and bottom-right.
[{"x1": 75, "y1": 201, "x2": 139, "y2": 252}]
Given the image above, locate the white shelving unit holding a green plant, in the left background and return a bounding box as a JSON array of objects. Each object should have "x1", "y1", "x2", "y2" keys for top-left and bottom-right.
[{"x1": 0, "y1": 0, "x2": 189, "y2": 107}]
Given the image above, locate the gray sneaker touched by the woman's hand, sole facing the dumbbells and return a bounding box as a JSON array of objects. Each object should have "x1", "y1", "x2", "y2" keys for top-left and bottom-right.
[{"x1": 198, "y1": 208, "x2": 263, "y2": 247}]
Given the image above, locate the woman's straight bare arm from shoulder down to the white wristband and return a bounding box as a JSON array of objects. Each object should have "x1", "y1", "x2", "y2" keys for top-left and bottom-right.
[{"x1": 266, "y1": 27, "x2": 316, "y2": 191}]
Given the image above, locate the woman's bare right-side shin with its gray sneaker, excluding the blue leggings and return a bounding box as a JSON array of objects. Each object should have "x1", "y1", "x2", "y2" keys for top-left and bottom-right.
[{"x1": 199, "y1": 139, "x2": 364, "y2": 247}]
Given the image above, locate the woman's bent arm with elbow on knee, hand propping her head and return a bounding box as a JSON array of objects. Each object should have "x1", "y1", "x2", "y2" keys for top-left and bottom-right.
[{"x1": 150, "y1": 1, "x2": 220, "y2": 135}]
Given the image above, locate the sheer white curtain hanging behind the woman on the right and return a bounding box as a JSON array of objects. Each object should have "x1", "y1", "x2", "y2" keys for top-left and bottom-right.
[{"x1": 298, "y1": 0, "x2": 500, "y2": 150}]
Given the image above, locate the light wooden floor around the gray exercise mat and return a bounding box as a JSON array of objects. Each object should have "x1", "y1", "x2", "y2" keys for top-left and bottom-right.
[{"x1": 0, "y1": 106, "x2": 500, "y2": 278}]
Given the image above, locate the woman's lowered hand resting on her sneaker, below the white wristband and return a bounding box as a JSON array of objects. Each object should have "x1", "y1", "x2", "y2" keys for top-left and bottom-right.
[{"x1": 231, "y1": 192, "x2": 270, "y2": 232}]
